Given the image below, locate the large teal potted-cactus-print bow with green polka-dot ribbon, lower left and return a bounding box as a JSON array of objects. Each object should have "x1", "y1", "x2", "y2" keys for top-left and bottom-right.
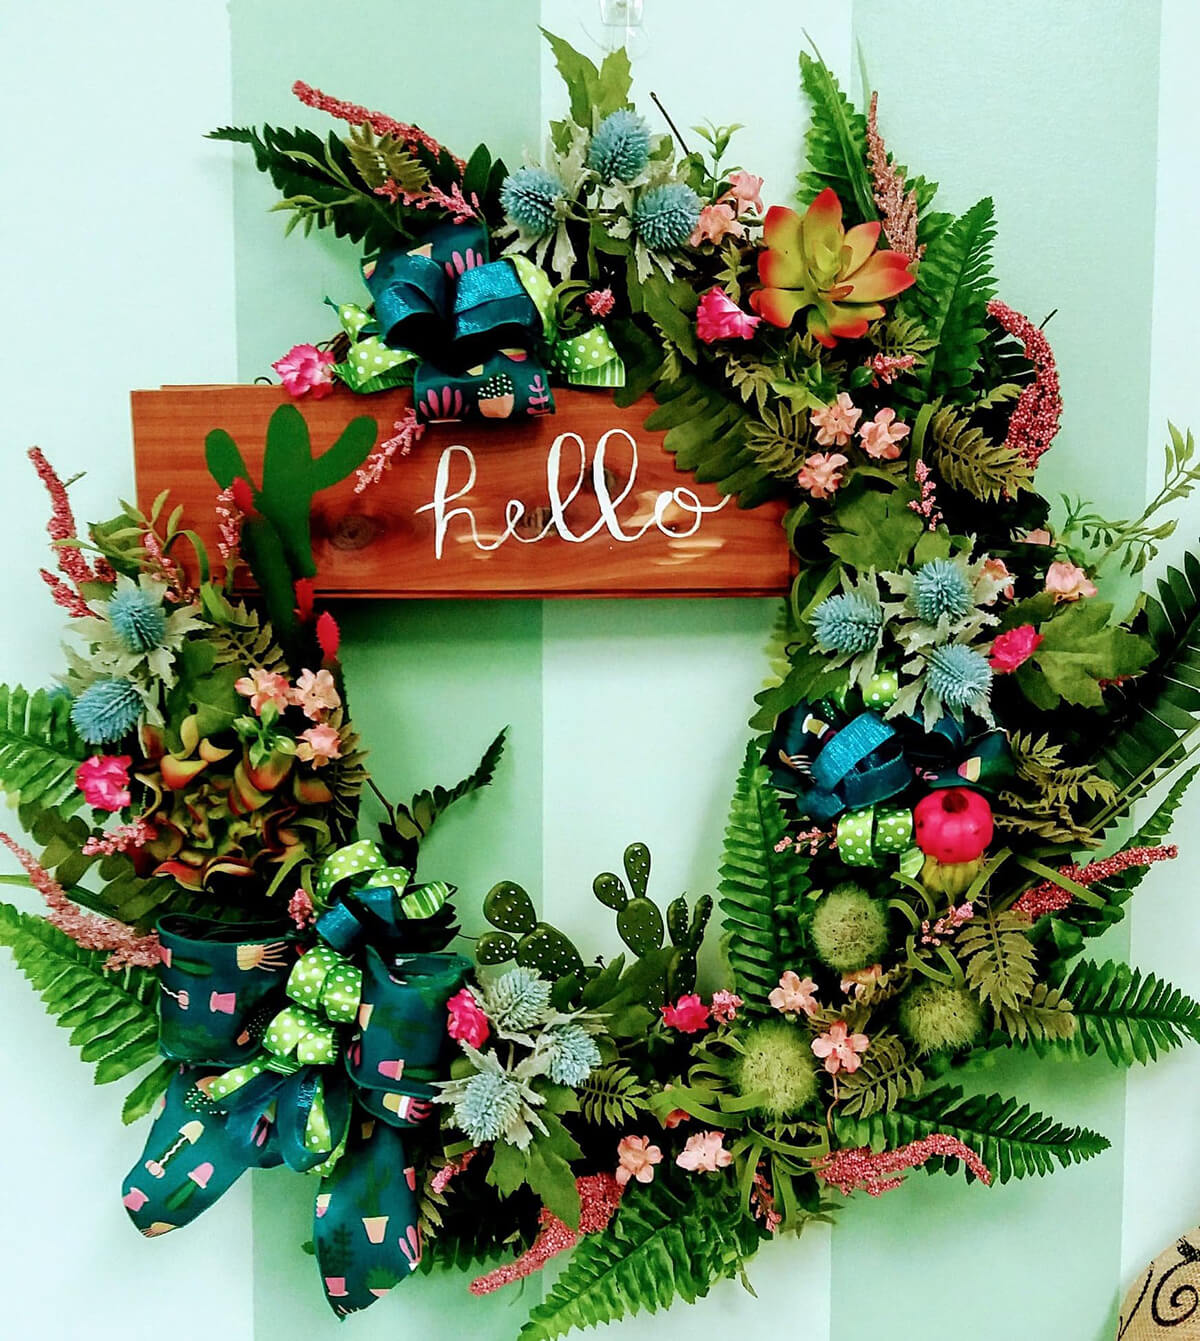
[{"x1": 122, "y1": 842, "x2": 471, "y2": 1316}]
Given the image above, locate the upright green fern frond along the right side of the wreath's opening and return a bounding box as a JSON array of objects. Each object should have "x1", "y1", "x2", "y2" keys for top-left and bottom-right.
[{"x1": 719, "y1": 743, "x2": 811, "y2": 1011}]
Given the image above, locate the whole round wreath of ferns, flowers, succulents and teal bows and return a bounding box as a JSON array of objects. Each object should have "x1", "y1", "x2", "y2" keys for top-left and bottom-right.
[{"x1": 0, "y1": 36, "x2": 1200, "y2": 1341}]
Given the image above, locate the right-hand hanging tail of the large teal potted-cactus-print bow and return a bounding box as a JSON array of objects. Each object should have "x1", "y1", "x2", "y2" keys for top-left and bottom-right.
[{"x1": 312, "y1": 1114, "x2": 421, "y2": 1318}]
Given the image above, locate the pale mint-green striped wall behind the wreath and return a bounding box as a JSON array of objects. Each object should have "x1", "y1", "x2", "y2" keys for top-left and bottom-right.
[{"x1": 0, "y1": 0, "x2": 1200, "y2": 1341}]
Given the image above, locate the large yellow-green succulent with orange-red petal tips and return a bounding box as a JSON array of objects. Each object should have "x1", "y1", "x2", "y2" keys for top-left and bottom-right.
[{"x1": 749, "y1": 186, "x2": 916, "y2": 349}]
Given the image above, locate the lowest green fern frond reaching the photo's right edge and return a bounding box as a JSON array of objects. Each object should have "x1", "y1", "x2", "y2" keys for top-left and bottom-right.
[{"x1": 1038, "y1": 959, "x2": 1200, "y2": 1066}]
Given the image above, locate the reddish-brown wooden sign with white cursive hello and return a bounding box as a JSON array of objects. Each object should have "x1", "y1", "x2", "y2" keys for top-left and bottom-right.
[{"x1": 133, "y1": 386, "x2": 791, "y2": 597}]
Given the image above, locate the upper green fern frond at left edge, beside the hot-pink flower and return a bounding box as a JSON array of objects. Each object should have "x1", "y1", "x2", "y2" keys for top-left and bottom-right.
[{"x1": 0, "y1": 685, "x2": 90, "y2": 815}]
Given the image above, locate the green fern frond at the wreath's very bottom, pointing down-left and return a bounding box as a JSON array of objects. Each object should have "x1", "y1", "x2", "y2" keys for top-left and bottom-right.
[{"x1": 520, "y1": 1177, "x2": 760, "y2": 1341}]
